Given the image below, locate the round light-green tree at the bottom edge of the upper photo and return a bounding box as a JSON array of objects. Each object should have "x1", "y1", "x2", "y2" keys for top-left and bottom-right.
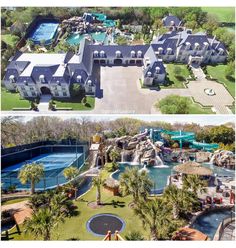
[{"x1": 157, "y1": 95, "x2": 191, "y2": 114}]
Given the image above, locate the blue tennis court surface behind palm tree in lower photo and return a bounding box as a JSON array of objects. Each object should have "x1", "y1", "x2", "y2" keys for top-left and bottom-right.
[{"x1": 1, "y1": 153, "x2": 84, "y2": 190}]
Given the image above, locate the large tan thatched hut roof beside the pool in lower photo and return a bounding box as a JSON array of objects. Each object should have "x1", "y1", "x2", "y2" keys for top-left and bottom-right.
[{"x1": 174, "y1": 161, "x2": 213, "y2": 176}]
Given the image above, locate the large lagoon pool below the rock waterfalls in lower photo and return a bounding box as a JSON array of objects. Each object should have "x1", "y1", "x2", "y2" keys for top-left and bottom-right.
[{"x1": 112, "y1": 163, "x2": 235, "y2": 194}]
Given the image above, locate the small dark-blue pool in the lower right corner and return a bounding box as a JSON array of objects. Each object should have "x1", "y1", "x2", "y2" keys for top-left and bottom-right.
[{"x1": 192, "y1": 210, "x2": 234, "y2": 239}]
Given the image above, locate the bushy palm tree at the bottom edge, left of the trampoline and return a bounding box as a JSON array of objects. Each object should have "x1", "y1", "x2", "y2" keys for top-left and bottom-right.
[{"x1": 23, "y1": 207, "x2": 64, "y2": 240}]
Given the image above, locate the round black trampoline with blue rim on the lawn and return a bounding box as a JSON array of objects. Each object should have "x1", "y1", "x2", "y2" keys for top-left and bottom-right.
[{"x1": 87, "y1": 214, "x2": 125, "y2": 236}]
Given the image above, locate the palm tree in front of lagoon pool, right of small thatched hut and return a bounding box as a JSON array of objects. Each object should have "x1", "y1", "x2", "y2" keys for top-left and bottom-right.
[{"x1": 120, "y1": 168, "x2": 153, "y2": 203}]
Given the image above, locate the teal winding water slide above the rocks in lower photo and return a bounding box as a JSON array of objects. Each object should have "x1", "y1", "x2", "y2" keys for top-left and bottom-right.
[{"x1": 163, "y1": 130, "x2": 219, "y2": 151}]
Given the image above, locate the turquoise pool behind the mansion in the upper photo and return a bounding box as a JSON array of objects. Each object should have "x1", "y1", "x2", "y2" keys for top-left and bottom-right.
[{"x1": 66, "y1": 32, "x2": 108, "y2": 45}]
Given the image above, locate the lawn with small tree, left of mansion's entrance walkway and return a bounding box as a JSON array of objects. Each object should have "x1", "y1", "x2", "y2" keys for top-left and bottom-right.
[{"x1": 160, "y1": 64, "x2": 190, "y2": 89}]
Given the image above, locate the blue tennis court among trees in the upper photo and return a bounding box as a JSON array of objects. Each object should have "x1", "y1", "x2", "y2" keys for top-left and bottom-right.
[{"x1": 29, "y1": 22, "x2": 59, "y2": 45}]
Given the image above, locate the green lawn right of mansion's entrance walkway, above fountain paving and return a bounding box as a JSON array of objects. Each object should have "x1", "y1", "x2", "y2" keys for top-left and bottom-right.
[{"x1": 207, "y1": 65, "x2": 235, "y2": 97}]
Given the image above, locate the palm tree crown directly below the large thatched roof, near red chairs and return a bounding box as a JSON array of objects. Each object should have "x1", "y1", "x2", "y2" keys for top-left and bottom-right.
[{"x1": 183, "y1": 175, "x2": 207, "y2": 197}]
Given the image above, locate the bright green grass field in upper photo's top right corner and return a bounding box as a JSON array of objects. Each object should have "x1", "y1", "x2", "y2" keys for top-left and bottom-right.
[{"x1": 202, "y1": 7, "x2": 235, "y2": 22}]
